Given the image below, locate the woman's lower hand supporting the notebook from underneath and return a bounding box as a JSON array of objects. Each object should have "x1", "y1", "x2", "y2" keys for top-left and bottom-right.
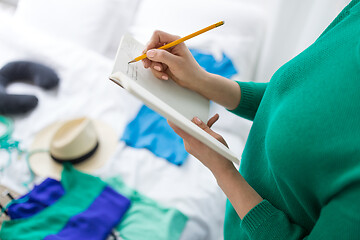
[{"x1": 168, "y1": 114, "x2": 235, "y2": 175}]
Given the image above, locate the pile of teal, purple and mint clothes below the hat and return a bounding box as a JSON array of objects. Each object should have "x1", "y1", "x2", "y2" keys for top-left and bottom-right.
[{"x1": 0, "y1": 164, "x2": 188, "y2": 240}]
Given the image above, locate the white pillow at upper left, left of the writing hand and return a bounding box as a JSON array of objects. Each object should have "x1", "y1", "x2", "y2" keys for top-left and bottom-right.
[{"x1": 15, "y1": 0, "x2": 139, "y2": 58}]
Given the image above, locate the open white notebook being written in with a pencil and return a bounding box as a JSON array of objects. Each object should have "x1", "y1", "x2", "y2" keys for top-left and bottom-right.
[{"x1": 110, "y1": 35, "x2": 239, "y2": 164}]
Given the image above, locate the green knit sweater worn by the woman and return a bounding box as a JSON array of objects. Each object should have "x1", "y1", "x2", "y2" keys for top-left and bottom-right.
[{"x1": 224, "y1": 0, "x2": 360, "y2": 240}]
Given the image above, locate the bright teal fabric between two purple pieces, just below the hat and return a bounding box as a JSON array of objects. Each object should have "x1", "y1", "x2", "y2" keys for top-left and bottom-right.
[{"x1": 0, "y1": 164, "x2": 106, "y2": 240}]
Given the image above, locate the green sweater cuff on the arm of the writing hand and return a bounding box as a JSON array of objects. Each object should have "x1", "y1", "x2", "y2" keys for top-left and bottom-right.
[{"x1": 229, "y1": 82, "x2": 268, "y2": 121}]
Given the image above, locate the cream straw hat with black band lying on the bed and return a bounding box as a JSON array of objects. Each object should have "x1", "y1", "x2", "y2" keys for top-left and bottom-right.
[{"x1": 29, "y1": 117, "x2": 117, "y2": 179}]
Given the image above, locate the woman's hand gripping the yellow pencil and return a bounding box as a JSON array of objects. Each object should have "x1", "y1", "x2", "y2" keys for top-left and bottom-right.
[{"x1": 142, "y1": 31, "x2": 208, "y2": 94}]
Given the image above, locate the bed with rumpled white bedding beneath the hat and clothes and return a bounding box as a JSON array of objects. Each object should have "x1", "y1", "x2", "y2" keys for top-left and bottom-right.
[{"x1": 0, "y1": 0, "x2": 264, "y2": 240}]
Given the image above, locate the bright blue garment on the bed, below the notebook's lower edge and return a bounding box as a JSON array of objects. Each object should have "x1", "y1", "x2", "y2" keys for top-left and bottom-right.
[{"x1": 121, "y1": 105, "x2": 189, "y2": 165}]
